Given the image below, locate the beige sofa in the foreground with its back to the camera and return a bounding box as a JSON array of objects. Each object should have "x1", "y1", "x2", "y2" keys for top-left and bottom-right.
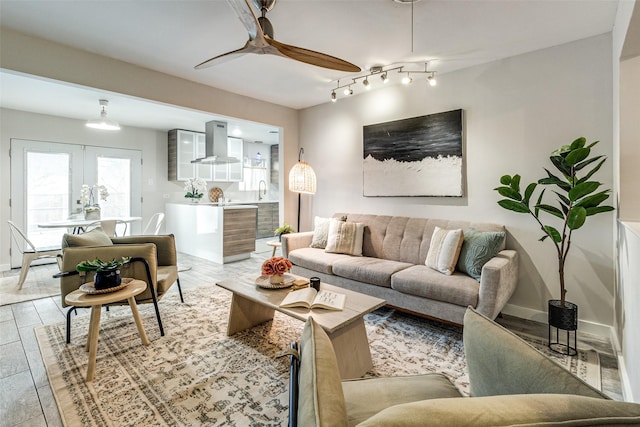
[{"x1": 289, "y1": 309, "x2": 640, "y2": 427}]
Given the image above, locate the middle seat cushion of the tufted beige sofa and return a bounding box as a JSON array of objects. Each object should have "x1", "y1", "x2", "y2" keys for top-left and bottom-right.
[{"x1": 332, "y1": 257, "x2": 412, "y2": 288}]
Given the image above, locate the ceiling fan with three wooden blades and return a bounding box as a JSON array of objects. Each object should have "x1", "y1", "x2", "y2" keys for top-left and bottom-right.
[{"x1": 194, "y1": 0, "x2": 362, "y2": 72}]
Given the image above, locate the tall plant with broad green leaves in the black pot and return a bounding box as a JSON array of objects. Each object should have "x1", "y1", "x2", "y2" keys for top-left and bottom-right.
[{"x1": 494, "y1": 137, "x2": 614, "y2": 307}]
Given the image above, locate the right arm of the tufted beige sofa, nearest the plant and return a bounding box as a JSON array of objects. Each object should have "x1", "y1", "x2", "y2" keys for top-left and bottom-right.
[{"x1": 476, "y1": 249, "x2": 518, "y2": 319}]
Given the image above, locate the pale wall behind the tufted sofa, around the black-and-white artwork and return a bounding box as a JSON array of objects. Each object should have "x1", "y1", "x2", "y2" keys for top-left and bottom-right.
[{"x1": 300, "y1": 34, "x2": 614, "y2": 325}]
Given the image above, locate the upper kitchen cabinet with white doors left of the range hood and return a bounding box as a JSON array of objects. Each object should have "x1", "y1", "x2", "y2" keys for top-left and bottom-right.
[{"x1": 168, "y1": 129, "x2": 213, "y2": 181}]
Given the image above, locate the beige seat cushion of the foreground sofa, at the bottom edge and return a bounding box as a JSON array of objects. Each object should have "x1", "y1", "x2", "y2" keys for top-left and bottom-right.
[{"x1": 342, "y1": 374, "x2": 461, "y2": 425}]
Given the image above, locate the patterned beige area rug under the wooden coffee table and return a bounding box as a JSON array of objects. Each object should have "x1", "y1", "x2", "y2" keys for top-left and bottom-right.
[{"x1": 36, "y1": 285, "x2": 600, "y2": 426}]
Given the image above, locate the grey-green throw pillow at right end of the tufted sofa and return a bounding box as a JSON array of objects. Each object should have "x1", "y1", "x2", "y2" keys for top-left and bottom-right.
[{"x1": 458, "y1": 228, "x2": 506, "y2": 282}]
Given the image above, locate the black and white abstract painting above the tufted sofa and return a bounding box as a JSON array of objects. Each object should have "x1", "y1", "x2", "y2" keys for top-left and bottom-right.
[{"x1": 363, "y1": 110, "x2": 463, "y2": 197}]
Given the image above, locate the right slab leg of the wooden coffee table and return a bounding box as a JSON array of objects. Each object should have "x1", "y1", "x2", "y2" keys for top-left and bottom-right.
[{"x1": 328, "y1": 317, "x2": 373, "y2": 379}]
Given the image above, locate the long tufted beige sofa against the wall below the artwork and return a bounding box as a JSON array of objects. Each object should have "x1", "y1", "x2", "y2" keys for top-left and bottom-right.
[{"x1": 282, "y1": 214, "x2": 518, "y2": 324}]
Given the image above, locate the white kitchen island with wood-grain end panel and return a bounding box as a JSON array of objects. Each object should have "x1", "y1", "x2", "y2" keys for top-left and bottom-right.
[{"x1": 165, "y1": 203, "x2": 258, "y2": 264}]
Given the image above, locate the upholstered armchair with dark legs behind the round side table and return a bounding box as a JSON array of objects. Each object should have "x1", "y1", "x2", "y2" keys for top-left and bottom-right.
[{"x1": 55, "y1": 228, "x2": 184, "y2": 342}]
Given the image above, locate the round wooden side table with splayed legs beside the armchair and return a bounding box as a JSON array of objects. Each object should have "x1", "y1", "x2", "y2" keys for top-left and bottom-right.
[{"x1": 64, "y1": 278, "x2": 149, "y2": 382}]
